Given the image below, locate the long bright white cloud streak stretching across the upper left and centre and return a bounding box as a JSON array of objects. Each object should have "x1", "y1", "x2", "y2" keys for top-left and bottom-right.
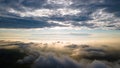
[{"x1": 9, "y1": 8, "x2": 81, "y2": 17}]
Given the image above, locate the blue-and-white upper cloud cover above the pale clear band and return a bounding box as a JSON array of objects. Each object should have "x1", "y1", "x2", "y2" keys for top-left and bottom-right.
[{"x1": 0, "y1": 0, "x2": 120, "y2": 30}]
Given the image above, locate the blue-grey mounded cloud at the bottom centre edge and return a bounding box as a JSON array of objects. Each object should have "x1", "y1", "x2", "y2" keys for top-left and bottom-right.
[{"x1": 32, "y1": 55, "x2": 81, "y2": 68}]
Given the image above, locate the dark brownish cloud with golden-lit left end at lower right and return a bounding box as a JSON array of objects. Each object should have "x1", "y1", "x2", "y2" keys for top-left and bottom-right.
[{"x1": 69, "y1": 45, "x2": 120, "y2": 62}]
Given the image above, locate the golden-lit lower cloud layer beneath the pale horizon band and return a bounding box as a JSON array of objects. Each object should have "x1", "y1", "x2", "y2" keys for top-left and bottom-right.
[{"x1": 0, "y1": 41, "x2": 120, "y2": 68}]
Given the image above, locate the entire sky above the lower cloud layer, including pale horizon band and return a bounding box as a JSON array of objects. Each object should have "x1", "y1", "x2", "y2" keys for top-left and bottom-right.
[{"x1": 0, "y1": 0, "x2": 120, "y2": 43}]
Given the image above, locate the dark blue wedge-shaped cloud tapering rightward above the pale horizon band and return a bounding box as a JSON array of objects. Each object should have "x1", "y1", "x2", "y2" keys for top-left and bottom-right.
[{"x1": 0, "y1": 17, "x2": 63, "y2": 28}]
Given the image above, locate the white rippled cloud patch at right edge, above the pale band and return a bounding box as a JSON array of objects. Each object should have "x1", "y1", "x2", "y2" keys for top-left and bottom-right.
[{"x1": 88, "y1": 9, "x2": 120, "y2": 29}]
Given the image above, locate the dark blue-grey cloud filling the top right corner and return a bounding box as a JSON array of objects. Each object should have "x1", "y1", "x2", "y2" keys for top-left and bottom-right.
[{"x1": 73, "y1": 0, "x2": 120, "y2": 13}]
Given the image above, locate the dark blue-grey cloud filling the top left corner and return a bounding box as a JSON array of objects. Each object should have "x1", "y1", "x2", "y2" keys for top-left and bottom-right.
[{"x1": 0, "y1": 0, "x2": 46, "y2": 10}]
